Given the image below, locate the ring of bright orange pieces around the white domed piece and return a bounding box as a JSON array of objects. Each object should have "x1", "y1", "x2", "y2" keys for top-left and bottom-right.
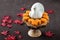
[{"x1": 23, "y1": 10, "x2": 49, "y2": 28}]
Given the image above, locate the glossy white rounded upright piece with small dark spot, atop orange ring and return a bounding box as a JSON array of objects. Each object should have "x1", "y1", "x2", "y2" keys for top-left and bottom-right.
[{"x1": 29, "y1": 2, "x2": 44, "y2": 18}]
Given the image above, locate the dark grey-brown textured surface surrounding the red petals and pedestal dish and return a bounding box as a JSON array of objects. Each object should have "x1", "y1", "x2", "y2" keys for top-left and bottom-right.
[{"x1": 0, "y1": 0, "x2": 60, "y2": 40}]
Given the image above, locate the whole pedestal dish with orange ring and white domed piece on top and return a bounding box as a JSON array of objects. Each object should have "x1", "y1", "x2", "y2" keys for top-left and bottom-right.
[{"x1": 23, "y1": 2, "x2": 49, "y2": 37}]
